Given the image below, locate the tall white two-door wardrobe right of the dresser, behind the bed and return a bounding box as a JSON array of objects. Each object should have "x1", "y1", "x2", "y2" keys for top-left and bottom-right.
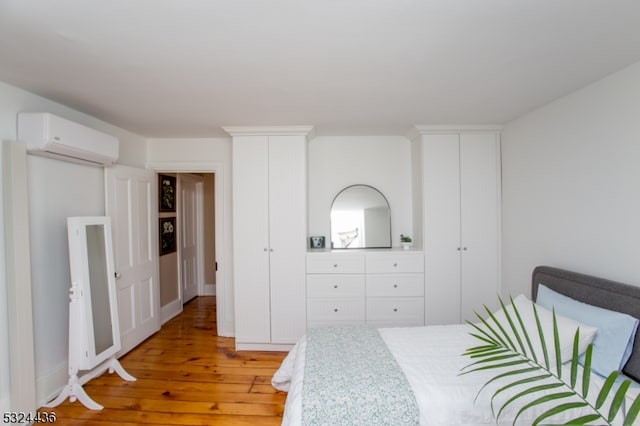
[{"x1": 412, "y1": 126, "x2": 500, "y2": 325}]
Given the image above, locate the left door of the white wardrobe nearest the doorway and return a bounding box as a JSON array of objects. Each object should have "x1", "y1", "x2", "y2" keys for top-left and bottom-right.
[{"x1": 233, "y1": 136, "x2": 271, "y2": 343}]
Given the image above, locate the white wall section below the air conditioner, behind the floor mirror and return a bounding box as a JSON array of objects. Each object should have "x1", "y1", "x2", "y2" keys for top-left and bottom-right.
[{"x1": 27, "y1": 156, "x2": 105, "y2": 402}]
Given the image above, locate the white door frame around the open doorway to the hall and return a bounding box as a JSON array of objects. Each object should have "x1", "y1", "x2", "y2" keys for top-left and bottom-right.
[{"x1": 146, "y1": 161, "x2": 235, "y2": 337}]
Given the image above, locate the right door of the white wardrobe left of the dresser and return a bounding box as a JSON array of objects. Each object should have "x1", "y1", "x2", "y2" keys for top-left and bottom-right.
[{"x1": 269, "y1": 136, "x2": 307, "y2": 343}]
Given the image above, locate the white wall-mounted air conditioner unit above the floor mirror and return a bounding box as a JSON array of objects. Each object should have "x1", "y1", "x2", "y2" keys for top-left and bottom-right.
[{"x1": 18, "y1": 112, "x2": 119, "y2": 166}]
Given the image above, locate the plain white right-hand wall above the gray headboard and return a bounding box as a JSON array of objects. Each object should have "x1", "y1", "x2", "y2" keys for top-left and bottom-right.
[{"x1": 502, "y1": 63, "x2": 640, "y2": 295}]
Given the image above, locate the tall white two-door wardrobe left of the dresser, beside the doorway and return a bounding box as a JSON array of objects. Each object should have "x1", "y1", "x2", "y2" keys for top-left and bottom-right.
[{"x1": 225, "y1": 126, "x2": 312, "y2": 350}]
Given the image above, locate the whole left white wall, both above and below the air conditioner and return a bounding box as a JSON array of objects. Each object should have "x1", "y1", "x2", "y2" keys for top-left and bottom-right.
[{"x1": 0, "y1": 82, "x2": 146, "y2": 404}]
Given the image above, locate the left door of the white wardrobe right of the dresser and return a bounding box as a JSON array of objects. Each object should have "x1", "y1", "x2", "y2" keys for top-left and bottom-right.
[{"x1": 422, "y1": 134, "x2": 461, "y2": 324}]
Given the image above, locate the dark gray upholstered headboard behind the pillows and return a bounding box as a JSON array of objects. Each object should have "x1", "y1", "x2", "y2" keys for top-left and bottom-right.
[{"x1": 531, "y1": 266, "x2": 640, "y2": 382}]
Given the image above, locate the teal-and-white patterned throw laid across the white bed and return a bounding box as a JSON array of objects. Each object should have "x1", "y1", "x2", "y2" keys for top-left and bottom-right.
[{"x1": 302, "y1": 325, "x2": 419, "y2": 426}]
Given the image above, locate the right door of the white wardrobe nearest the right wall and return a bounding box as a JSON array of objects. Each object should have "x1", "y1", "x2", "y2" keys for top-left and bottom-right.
[{"x1": 460, "y1": 134, "x2": 500, "y2": 321}]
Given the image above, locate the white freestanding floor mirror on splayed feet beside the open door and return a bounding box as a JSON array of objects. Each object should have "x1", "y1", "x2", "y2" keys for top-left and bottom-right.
[{"x1": 46, "y1": 216, "x2": 136, "y2": 410}]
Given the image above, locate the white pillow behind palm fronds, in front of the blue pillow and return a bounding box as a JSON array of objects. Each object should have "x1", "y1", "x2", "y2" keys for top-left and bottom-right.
[{"x1": 486, "y1": 294, "x2": 598, "y2": 365}]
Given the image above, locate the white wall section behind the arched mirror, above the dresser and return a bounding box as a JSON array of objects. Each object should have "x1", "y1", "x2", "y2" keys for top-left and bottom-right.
[{"x1": 308, "y1": 136, "x2": 412, "y2": 247}]
